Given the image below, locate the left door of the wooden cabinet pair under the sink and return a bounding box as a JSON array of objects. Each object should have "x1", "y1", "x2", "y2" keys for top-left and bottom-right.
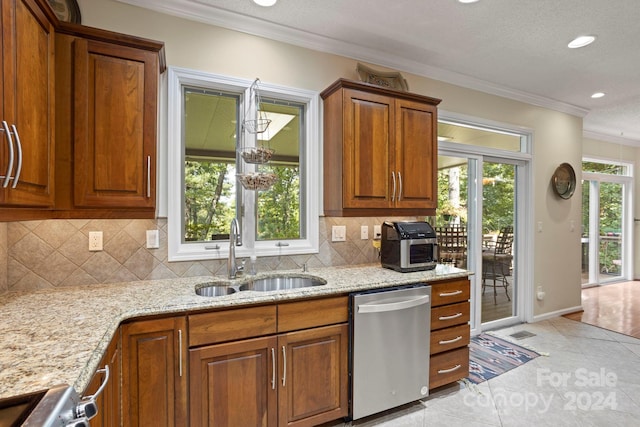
[{"x1": 189, "y1": 337, "x2": 278, "y2": 427}]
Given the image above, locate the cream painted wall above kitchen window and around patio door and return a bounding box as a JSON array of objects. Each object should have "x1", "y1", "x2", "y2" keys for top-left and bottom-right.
[{"x1": 78, "y1": 0, "x2": 582, "y2": 315}]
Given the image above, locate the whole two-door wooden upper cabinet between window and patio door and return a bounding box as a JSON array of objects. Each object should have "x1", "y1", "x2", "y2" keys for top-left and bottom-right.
[{"x1": 321, "y1": 79, "x2": 440, "y2": 216}]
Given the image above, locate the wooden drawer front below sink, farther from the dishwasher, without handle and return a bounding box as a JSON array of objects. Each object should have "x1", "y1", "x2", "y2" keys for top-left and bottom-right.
[{"x1": 189, "y1": 305, "x2": 276, "y2": 347}]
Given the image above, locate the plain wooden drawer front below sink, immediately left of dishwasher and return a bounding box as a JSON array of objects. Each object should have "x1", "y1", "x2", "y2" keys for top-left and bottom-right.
[{"x1": 278, "y1": 296, "x2": 349, "y2": 332}]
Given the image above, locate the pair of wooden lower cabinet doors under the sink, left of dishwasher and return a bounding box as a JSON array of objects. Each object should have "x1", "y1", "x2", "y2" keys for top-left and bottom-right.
[{"x1": 189, "y1": 324, "x2": 348, "y2": 427}]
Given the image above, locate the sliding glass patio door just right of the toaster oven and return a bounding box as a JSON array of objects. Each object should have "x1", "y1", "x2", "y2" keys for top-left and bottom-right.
[{"x1": 440, "y1": 150, "x2": 521, "y2": 329}]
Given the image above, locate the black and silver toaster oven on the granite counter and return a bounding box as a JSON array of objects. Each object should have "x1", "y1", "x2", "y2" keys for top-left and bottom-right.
[{"x1": 380, "y1": 221, "x2": 438, "y2": 273}]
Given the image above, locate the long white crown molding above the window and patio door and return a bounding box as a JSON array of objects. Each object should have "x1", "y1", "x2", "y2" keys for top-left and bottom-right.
[{"x1": 117, "y1": 0, "x2": 589, "y2": 117}]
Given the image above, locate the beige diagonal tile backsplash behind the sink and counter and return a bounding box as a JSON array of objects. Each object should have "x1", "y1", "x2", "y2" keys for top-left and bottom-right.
[{"x1": 0, "y1": 218, "x2": 412, "y2": 292}]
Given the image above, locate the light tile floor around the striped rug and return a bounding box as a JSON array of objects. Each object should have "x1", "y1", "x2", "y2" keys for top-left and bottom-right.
[{"x1": 325, "y1": 317, "x2": 640, "y2": 427}]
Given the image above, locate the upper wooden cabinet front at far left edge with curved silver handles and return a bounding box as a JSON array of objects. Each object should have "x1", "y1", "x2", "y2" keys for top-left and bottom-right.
[{"x1": 0, "y1": 0, "x2": 55, "y2": 207}]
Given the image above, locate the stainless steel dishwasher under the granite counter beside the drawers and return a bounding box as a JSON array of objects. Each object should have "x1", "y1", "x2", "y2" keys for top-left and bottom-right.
[{"x1": 350, "y1": 285, "x2": 431, "y2": 420}]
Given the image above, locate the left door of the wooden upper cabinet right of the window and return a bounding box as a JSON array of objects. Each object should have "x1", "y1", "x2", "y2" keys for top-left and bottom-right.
[{"x1": 342, "y1": 90, "x2": 397, "y2": 208}]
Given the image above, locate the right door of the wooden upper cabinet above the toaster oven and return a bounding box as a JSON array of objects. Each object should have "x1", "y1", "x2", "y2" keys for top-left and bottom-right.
[{"x1": 395, "y1": 99, "x2": 438, "y2": 209}]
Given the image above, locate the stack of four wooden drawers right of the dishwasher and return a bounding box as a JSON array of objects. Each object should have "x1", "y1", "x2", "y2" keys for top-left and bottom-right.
[{"x1": 429, "y1": 279, "x2": 471, "y2": 389}]
